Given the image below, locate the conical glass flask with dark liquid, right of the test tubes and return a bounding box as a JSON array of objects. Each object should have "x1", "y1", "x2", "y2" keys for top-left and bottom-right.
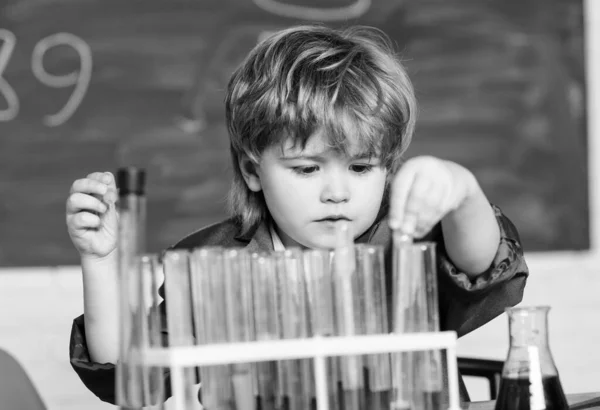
[{"x1": 496, "y1": 306, "x2": 569, "y2": 410}]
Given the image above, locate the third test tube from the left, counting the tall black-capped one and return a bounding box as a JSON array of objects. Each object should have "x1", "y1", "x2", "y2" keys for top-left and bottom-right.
[{"x1": 163, "y1": 249, "x2": 198, "y2": 408}]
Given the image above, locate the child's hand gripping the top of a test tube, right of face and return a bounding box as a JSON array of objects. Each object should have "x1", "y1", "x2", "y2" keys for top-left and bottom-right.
[{"x1": 389, "y1": 156, "x2": 478, "y2": 238}]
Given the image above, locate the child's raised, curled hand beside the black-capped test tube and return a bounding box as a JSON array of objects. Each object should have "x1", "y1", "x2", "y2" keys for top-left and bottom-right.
[{"x1": 67, "y1": 172, "x2": 118, "y2": 258}]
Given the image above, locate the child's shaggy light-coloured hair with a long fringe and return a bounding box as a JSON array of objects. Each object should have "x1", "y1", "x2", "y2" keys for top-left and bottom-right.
[{"x1": 225, "y1": 25, "x2": 416, "y2": 233}]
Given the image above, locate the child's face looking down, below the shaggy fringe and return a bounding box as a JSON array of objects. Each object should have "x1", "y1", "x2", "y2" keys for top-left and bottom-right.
[{"x1": 251, "y1": 132, "x2": 386, "y2": 248}]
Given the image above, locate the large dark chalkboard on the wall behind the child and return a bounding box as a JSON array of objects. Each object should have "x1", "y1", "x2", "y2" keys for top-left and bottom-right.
[{"x1": 0, "y1": 0, "x2": 589, "y2": 266}]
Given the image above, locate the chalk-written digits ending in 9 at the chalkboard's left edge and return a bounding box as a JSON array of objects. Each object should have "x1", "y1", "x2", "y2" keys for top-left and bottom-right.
[{"x1": 0, "y1": 28, "x2": 92, "y2": 127}]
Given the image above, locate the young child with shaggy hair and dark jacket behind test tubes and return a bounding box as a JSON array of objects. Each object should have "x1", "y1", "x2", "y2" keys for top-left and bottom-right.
[{"x1": 67, "y1": 26, "x2": 528, "y2": 401}]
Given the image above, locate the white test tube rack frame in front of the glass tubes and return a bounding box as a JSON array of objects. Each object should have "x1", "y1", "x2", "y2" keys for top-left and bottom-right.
[{"x1": 138, "y1": 331, "x2": 460, "y2": 410}]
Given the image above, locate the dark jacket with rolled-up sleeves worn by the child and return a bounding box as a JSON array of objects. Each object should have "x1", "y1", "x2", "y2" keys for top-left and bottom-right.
[{"x1": 69, "y1": 206, "x2": 528, "y2": 403}]
